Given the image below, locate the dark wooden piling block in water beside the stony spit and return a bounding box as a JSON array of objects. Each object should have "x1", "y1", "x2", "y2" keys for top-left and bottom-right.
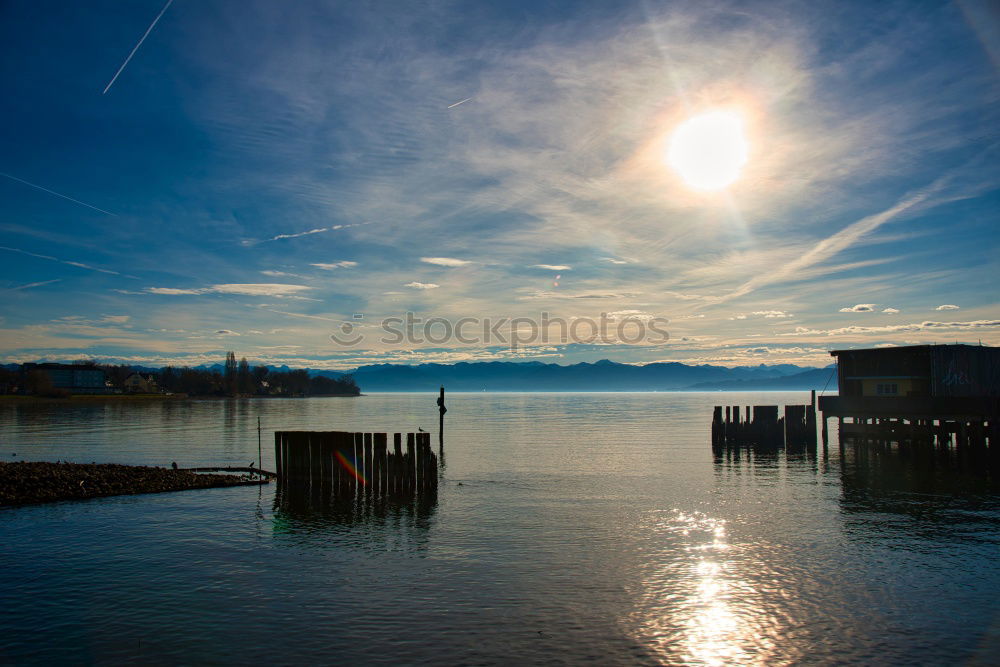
[{"x1": 274, "y1": 431, "x2": 438, "y2": 496}]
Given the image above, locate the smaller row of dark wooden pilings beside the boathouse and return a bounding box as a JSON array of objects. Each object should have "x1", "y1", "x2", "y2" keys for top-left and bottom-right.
[{"x1": 712, "y1": 405, "x2": 816, "y2": 449}]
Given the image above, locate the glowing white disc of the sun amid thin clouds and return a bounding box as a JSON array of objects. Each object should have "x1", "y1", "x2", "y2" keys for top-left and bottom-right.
[{"x1": 666, "y1": 111, "x2": 749, "y2": 190}]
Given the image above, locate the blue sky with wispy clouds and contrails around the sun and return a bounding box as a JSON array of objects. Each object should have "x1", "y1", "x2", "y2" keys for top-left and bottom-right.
[{"x1": 0, "y1": 0, "x2": 1000, "y2": 369}]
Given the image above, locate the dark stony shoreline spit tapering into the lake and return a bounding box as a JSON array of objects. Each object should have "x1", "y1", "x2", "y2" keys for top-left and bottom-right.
[{"x1": 0, "y1": 461, "x2": 267, "y2": 507}]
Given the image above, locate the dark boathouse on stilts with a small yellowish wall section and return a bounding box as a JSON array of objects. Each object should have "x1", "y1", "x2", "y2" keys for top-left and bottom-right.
[{"x1": 819, "y1": 344, "x2": 1000, "y2": 442}]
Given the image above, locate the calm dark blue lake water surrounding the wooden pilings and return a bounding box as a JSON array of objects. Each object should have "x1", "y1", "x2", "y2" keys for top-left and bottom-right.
[{"x1": 0, "y1": 393, "x2": 1000, "y2": 665}]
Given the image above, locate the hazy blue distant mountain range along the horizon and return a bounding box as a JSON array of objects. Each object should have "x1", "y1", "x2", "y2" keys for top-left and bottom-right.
[{"x1": 5, "y1": 359, "x2": 836, "y2": 392}]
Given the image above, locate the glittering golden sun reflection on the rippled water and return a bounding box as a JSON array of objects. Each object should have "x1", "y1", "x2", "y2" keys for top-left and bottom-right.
[{"x1": 629, "y1": 511, "x2": 777, "y2": 665}]
